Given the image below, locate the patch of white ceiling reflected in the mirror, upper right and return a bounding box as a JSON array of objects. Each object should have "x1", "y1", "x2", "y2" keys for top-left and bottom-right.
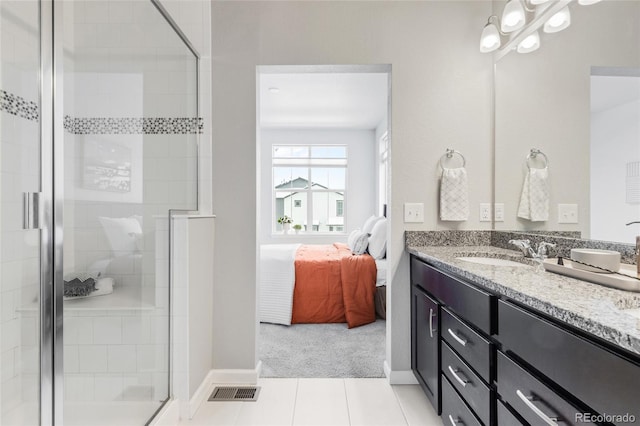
[{"x1": 591, "y1": 75, "x2": 640, "y2": 112}]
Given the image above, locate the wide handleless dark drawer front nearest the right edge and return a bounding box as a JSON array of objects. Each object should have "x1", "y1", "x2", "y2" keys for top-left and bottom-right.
[{"x1": 498, "y1": 301, "x2": 640, "y2": 419}]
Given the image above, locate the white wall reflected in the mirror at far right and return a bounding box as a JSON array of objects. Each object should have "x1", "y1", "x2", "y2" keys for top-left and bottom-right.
[{"x1": 590, "y1": 97, "x2": 640, "y2": 244}]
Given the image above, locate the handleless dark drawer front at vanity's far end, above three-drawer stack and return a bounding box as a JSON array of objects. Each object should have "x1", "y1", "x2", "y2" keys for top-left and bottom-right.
[{"x1": 411, "y1": 256, "x2": 497, "y2": 335}]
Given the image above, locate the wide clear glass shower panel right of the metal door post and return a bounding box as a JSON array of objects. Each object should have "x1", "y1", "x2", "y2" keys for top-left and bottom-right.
[{"x1": 61, "y1": 0, "x2": 200, "y2": 426}]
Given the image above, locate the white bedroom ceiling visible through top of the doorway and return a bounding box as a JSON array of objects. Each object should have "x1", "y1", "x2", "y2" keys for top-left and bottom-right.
[{"x1": 259, "y1": 72, "x2": 388, "y2": 129}]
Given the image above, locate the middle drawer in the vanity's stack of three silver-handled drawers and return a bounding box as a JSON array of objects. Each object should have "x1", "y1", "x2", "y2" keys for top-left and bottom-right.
[{"x1": 442, "y1": 343, "x2": 492, "y2": 425}]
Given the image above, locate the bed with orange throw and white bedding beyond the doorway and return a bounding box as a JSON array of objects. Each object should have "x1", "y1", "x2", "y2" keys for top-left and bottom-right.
[{"x1": 259, "y1": 215, "x2": 386, "y2": 328}]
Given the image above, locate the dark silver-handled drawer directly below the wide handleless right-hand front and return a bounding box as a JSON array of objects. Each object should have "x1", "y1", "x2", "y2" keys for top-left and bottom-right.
[{"x1": 497, "y1": 352, "x2": 593, "y2": 425}]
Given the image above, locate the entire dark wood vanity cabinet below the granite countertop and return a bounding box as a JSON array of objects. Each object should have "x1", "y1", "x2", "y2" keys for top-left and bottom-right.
[{"x1": 410, "y1": 256, "x2": 640, "y2": 426}]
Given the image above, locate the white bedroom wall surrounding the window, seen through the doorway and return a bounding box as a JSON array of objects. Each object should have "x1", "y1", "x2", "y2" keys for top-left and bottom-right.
[{"x1": 259, "y1": 129, "x2": 377, "y2": 244}]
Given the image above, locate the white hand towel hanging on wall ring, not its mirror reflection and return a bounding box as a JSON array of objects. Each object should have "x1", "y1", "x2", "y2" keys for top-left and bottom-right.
[{"x1": 440, "y1": 167, "x2": 469, "y2": 221}]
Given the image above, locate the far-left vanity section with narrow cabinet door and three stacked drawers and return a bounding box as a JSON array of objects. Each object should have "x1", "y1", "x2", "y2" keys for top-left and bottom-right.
[{"x1": 411, "y1": 257, "x2": 497, "y2": 425}]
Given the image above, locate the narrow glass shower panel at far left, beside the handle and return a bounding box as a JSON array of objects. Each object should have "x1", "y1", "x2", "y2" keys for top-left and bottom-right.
[{"x1": 0, "y1": 0, "x2": 41, "y2": 425}]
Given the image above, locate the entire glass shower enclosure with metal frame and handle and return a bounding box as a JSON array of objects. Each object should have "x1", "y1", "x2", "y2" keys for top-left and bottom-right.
[{"x1": 0, "y1": 0, "x2": 202, "y2": 425}]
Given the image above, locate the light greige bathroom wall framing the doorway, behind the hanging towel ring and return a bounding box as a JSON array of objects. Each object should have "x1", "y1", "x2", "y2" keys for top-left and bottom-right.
[{"x1": 212, "y1": 1, "x2": 492, "y2": 372}]
